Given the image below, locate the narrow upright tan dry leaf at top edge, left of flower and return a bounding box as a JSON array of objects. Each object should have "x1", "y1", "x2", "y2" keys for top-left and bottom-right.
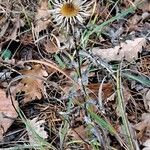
[{"x1": 34, "y1": 0, "x2": 51, "y2": 39}]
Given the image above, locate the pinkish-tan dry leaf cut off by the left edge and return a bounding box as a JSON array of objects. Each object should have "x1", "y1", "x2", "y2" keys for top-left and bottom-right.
[{"x1": 0, "y1": 89, "x2": 18, "y2": 141}]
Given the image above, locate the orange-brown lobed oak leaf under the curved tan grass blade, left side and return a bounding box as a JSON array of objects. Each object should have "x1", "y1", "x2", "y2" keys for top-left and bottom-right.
[{"x1": 16, "y1": 65, "x2": 47, "y2": 103}]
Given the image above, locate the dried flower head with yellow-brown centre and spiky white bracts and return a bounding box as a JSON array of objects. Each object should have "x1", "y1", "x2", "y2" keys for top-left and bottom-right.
[{"x1": 51, "y1": 0, "x2": 93, "y2": 32}]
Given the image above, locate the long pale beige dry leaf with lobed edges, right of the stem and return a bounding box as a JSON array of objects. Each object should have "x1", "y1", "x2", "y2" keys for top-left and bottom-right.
[{"x1": 92, "y1": 38, "x2": 146, "y2": 61}]
